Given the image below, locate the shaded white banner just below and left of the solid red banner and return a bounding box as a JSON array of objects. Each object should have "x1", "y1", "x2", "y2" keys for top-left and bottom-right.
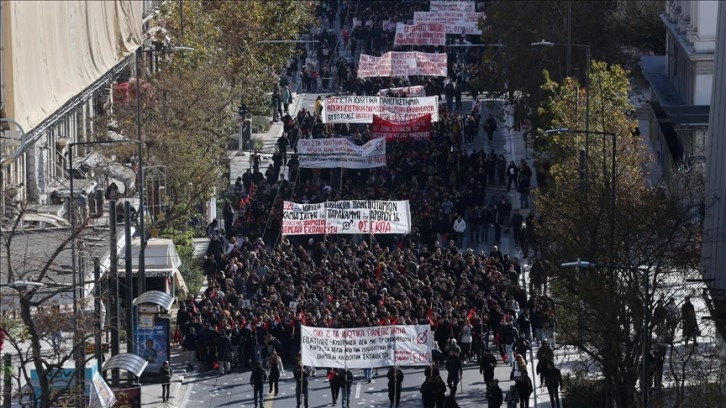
[{"x1": 298, "y1": 138, "x2": 386, "y2": 169}]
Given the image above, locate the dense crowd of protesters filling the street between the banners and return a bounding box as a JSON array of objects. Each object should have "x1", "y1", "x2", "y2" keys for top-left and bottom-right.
[{"x1": 177, "y1": 1, "x2": 555, "y2": 406}]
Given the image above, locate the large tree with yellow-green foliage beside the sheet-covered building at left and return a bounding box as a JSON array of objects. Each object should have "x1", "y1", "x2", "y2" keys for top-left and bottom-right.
[{"x1": 116, "y1": 0, "x2": 314, "y2": 230}]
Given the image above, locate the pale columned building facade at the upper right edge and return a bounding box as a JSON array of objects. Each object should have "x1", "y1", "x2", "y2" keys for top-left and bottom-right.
[{"x1": 641, "y1": 0, "x2": 719, "y2": 186}]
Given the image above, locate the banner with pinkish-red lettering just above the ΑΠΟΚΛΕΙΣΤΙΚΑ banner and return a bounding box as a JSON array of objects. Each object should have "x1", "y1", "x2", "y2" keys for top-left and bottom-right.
[{"x1": 358, "y1": 51, "x2": 447, "y2": 78}]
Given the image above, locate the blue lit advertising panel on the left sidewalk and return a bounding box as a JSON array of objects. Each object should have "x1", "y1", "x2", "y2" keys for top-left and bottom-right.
[{"x1": 134, "y1": 317, "x2": 171, "y2": 376}]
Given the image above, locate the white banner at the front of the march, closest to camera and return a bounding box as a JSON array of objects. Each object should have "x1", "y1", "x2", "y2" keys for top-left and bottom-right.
[{"x1": 300, "y1": 325, "x2": 433, "y2": 368}]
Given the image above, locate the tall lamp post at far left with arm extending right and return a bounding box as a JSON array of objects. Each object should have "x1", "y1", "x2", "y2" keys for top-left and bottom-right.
[{"x1": 68, "y1": 140, "x2": 140, "y2": 405}]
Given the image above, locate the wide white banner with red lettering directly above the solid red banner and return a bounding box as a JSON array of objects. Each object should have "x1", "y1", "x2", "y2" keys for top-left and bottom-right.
[{"x1": 322, "y1": 96, "x2": 439, "y2": 123}]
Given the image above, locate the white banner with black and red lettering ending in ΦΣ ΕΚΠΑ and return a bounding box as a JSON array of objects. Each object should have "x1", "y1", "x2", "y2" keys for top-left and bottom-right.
[{"x1": 282, "y1": 200, "x2": 411, "y2": 235}]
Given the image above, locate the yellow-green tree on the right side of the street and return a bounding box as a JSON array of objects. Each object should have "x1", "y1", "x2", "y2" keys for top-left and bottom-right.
[{"x1": 536, "y1": 62, "x2": 702, "y2": 407}]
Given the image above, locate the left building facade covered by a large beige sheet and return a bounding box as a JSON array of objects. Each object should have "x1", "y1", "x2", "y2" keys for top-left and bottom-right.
[{"x1": 0, "y1": 0, "x2": 161, "y2": 225}]
